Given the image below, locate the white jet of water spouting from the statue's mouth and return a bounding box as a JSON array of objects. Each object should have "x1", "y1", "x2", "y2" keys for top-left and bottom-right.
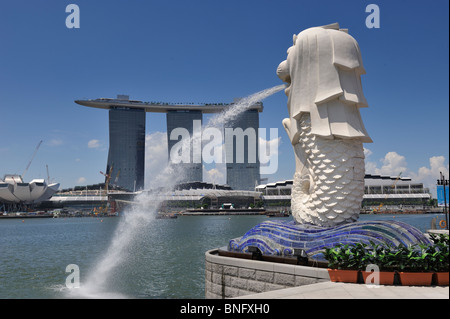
[{"x1": 68, "y1": 84, "x2": 286, "y2": 298}]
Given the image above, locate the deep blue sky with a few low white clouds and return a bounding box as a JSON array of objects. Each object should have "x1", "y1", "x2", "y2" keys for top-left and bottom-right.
[{"x1": 0, "y1": 0, "x2": 449, "y2": 196}]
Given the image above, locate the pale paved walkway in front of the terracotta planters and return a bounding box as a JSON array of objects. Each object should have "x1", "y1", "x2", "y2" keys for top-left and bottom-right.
[{"x1": 234, "y1": 282, "x2": 449, "y2": 299}]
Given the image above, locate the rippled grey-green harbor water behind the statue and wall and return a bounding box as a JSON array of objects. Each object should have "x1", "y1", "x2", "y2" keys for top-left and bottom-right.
[{"x1": 0, "y1": 214, "x2": 445, "y2": 299}]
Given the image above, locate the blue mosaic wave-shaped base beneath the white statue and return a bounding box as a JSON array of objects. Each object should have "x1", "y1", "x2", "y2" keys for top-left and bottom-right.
[{"x1": 228, "y1": 221, "x2": 431, "y2": 261}]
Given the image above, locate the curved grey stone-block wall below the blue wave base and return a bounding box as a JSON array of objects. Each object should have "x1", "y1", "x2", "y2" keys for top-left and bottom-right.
[{"x1": 205, "y1": 249, "x2": 330, "y2": 299}]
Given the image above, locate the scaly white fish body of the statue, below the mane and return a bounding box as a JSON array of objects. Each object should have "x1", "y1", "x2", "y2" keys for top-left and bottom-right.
[{"x1": 291, "y1": 113, "x2": 365, "y2": 227}]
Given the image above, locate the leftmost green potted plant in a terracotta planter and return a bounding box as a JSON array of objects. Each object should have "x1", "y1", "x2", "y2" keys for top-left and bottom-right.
[{"x1": 324, "y1": 244, "x2": 365, "y2": 283}]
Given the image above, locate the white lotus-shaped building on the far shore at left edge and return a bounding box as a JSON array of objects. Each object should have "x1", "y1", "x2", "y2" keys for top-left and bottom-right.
[{"x1": 0, "y1": 175, "x2": 59, "y2": 204}]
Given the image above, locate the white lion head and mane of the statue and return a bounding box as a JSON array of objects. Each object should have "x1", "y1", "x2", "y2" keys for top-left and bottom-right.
[{"x1": 277, "y1": 23, "x2": 372, "y2": 144}]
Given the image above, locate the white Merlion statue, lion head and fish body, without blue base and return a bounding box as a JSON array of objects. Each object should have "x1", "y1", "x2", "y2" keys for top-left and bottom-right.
[{"x1": 277, "y1": 23, "x2": 372, "y2": 227}]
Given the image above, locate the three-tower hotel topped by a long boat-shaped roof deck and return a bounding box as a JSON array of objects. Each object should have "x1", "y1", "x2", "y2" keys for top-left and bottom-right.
[{"x1": 75, "y1": 95, "x2": 263, "y2": 191}]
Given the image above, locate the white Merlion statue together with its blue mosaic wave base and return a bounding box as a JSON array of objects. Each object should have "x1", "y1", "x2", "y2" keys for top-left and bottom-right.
[{"x1": 228, "y1": 23, "x2": 431, "y2": 261}]
